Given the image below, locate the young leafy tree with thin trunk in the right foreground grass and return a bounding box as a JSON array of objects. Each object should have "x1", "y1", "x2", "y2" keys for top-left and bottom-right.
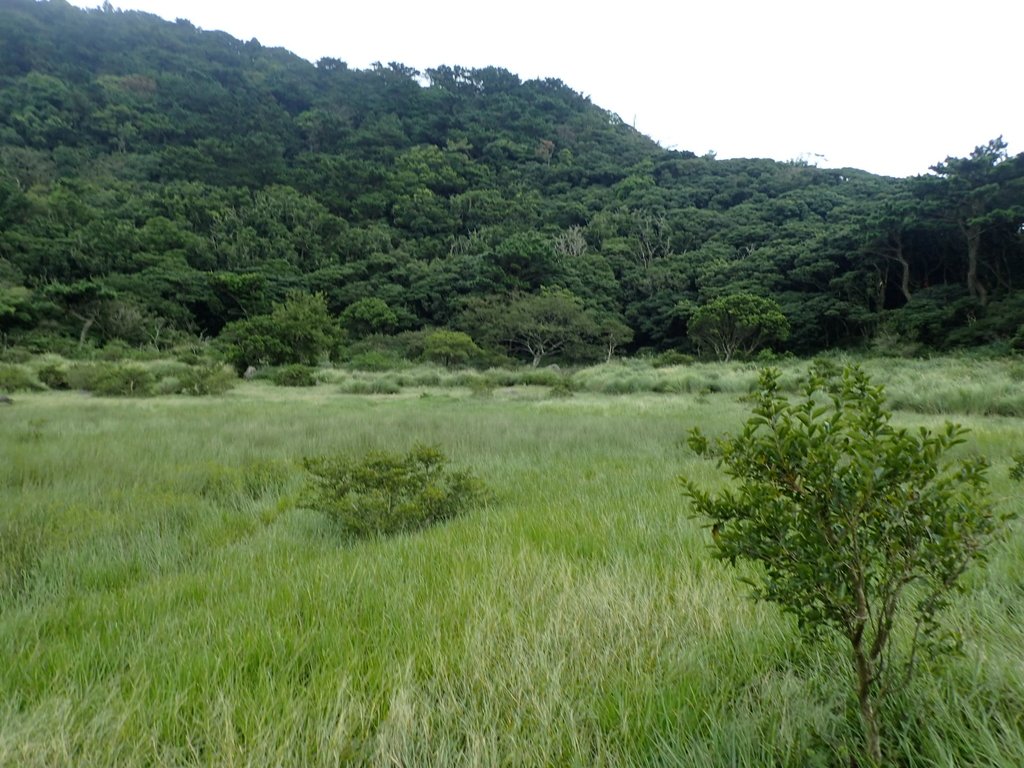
[{"x1": 684, "y1": 367, "x2": 999, "y2": 765}]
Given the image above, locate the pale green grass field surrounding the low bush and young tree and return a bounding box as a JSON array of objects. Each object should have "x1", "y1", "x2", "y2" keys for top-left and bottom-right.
[{"x1": 0, "y1": 361, "x2": 1024, "y2": 766}]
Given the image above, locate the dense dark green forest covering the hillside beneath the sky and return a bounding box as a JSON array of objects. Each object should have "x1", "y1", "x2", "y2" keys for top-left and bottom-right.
[{"x1": 0, "y1": 0, "x2": 1024, "y2": 361}]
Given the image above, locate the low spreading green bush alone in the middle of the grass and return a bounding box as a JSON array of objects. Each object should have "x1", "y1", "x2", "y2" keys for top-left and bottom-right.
[{"x1": 302, "y1": 445, "x2": 483, "y2": 537}]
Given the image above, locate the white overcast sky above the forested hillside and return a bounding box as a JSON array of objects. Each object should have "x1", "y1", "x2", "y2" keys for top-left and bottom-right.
[{"x1": 68, "y1": 0, "x2": 1024, "y2": 176}]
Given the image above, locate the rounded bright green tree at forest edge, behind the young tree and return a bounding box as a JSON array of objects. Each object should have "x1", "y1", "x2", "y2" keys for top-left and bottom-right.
[{"x1": 689, "y1": 293, "x2": 790, "y2": 361}]
